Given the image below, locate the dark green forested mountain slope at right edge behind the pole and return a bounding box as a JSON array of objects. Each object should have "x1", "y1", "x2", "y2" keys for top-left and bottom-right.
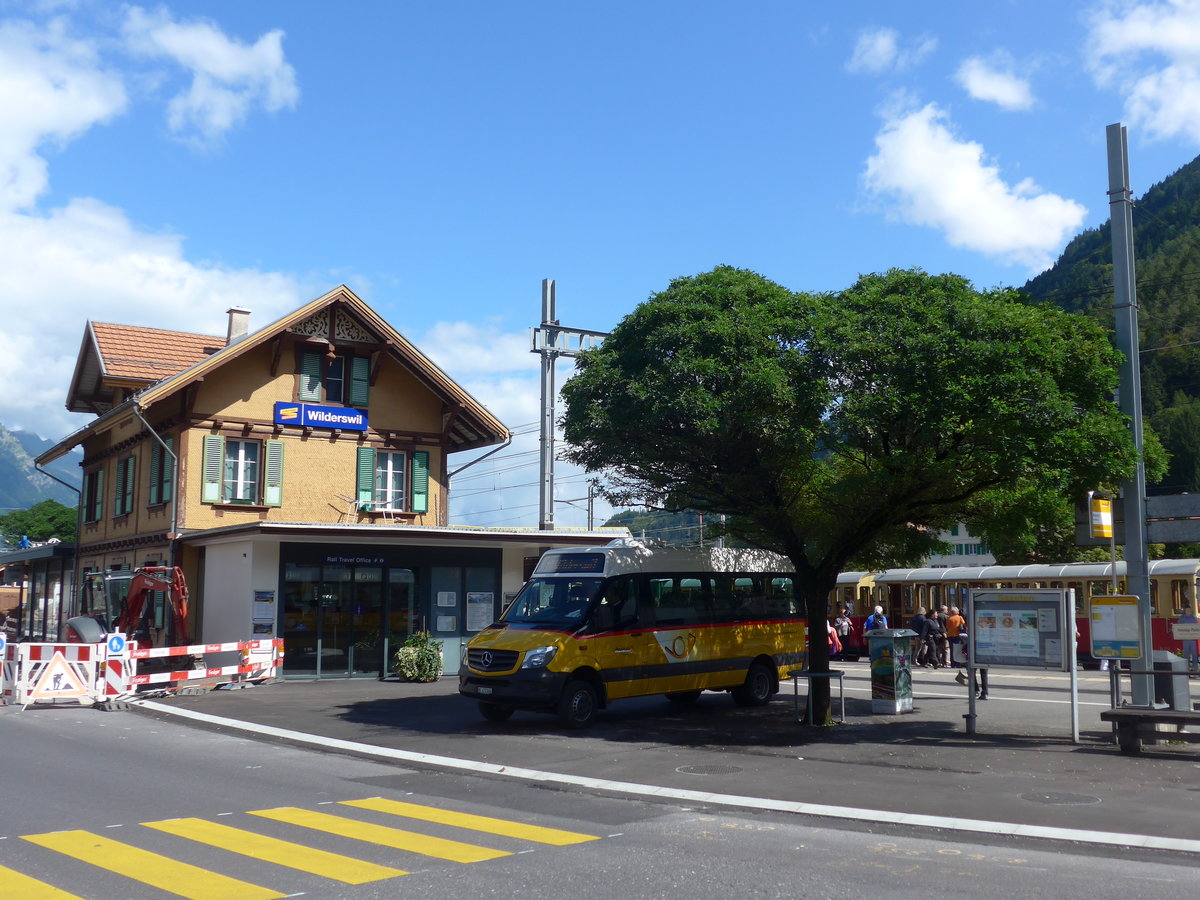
[{"x1": 1021, "y1": 151, "x2": 1200, "y2": 493}]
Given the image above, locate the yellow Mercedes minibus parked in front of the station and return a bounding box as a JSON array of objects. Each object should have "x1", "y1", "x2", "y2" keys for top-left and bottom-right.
[{"x1": 458, "y1": 539, "x2": 808, "y2": 728}]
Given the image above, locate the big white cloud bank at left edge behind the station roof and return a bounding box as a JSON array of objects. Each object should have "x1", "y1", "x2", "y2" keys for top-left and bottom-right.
[{"x1": 0, "y1": 10, "x2": 308, "y2": 439}]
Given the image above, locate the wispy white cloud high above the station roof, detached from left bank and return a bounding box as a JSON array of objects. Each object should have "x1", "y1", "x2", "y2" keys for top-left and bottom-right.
[{"x1": 125, "y1": 6, "x2": 300, "y2": 144}]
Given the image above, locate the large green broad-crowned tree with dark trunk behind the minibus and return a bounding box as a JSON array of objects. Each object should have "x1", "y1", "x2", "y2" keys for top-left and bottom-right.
[{"x1": 563, "y1": 266, "x2": 1135, "y2": 721}]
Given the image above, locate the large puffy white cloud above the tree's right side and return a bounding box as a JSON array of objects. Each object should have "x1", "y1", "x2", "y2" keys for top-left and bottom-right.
[{"x1": 864, "y1": 103, "x2": 1087, "y2": 270}]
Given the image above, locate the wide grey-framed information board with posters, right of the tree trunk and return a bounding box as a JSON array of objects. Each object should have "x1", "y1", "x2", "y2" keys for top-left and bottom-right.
[{"x1": 967, "y1": 589, "x2": 1075, "y2": 672}]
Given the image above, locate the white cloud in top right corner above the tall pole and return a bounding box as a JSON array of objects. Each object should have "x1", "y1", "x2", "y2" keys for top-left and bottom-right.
[{"x1": 1086, "y1": 0, "x2": 1200, "y2": 142}]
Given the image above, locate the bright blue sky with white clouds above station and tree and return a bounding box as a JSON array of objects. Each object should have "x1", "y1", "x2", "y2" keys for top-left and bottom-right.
[{"x1": 7, "y1": 0, "x2": 1200, "y2": 524}]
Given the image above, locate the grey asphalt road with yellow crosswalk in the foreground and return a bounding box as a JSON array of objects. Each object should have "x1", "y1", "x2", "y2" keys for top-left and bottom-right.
[{"x1": 0, "y1": 705, "x2": 1196, "y2": 900}]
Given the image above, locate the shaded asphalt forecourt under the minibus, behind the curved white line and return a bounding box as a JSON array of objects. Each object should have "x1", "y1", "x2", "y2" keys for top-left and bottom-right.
[{"x1": 131, "y1": 662, "x2": 1200, "y2": 850}]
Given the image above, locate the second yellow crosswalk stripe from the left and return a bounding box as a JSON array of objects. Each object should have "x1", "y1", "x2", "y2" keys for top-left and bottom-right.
[{"x1": 22, "y1": 832, "x2": 287, "y2": 900}]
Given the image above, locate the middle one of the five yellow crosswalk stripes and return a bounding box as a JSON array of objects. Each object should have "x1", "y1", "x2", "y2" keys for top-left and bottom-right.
[{"x1": 142, "y1": 818, "x2": 408, "y2": 884}]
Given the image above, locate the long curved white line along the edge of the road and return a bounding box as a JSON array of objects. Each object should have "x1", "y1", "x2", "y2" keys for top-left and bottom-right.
[{"x1": 137, "y1": 700, "x2": 1200, "y2": 853}]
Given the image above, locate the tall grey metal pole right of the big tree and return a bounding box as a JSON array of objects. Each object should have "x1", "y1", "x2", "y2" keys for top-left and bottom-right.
[{"x1": 1105, "y1": 122, "x2": 1154, "y2": 707}]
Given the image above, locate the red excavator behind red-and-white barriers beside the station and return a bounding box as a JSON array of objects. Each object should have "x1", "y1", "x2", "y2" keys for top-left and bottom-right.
[{"x1": 67, "y1": 565, "x2": 191, "y2": 667}]
